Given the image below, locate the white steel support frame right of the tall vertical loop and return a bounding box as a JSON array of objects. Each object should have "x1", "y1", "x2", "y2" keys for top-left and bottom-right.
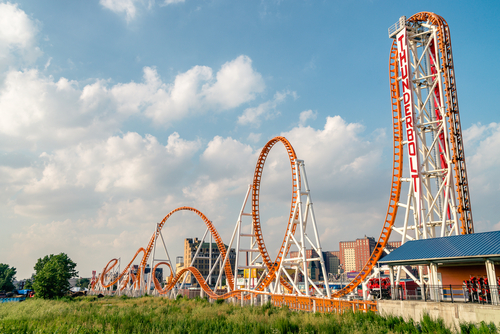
[{"x1": 273, "y1": 160, "x2": 331, "y2": 297}]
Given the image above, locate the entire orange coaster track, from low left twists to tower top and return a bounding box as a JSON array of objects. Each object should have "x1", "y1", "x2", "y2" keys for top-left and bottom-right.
[{"x1": 92, "y1": 12, "x2": 474, "y2": 310}]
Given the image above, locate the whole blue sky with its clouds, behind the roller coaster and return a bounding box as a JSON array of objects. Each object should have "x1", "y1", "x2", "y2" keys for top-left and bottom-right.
[{"x1": 0, "y1": 0, "x2": 500, "y2": 278}]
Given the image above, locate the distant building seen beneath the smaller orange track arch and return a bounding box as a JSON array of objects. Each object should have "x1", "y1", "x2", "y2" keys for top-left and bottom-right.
[{"x1": 181, "y1": 238, "x2": 236, "y2": 285}]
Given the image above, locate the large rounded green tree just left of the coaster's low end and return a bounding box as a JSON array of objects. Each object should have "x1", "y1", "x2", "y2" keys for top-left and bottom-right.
[{"x1": 33, "y1": 253, "x2": 78, "y2": 299}]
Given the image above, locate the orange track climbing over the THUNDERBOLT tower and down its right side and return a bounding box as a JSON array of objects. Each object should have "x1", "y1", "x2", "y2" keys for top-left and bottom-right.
[{"x1": 332, "y1": 12, "x2": 474, "y2": 297}]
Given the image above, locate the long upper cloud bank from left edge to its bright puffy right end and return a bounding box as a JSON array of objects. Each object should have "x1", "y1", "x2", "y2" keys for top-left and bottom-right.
[{"x1": 0, "y1": 56, "x2": 266, "y2": 149}]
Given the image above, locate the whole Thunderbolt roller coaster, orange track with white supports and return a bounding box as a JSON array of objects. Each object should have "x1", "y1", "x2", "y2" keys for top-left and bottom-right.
[{"x1": 92, "y1": 12, "x2": 474, "y2": 311}]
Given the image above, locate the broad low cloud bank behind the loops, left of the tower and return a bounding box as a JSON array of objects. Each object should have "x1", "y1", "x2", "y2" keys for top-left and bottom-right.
[{"x1": 0, "y1": 116, "x2": 389, "y2": 272}]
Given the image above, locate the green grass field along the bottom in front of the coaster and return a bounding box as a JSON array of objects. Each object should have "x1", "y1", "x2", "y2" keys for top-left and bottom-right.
[{"x1": 0, "y1": 297, "x2": 497, "y2": 334}]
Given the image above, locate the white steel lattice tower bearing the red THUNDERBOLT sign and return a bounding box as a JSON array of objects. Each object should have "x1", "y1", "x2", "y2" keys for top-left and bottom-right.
[{"x1": 389, "y1": 17, "x2": 460, "y2": 287}]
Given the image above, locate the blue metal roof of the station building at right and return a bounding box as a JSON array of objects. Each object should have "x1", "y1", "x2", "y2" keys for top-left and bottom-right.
[{"x1": 379, "y1": 231, "x2": 500, "y2": 264}]
